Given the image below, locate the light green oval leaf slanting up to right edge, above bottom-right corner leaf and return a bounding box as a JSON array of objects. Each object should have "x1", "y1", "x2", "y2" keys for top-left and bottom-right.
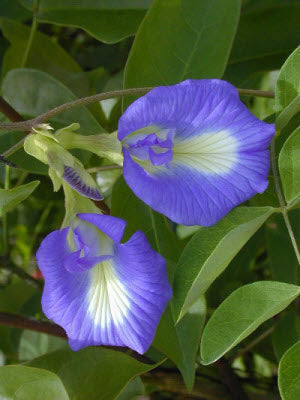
[{"x1": 201, "y1": 281, "x2": 300, "y2": 365}]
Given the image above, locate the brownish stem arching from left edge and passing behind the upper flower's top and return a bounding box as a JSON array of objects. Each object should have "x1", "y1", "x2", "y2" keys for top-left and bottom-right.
[{"x1": 0, "y1": 87, "x2": 274, "y2": 131}]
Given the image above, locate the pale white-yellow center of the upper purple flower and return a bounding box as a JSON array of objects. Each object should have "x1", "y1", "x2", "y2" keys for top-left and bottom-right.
[{"x1": 172, "y1": 131, "x2": 238, "y2": 174}]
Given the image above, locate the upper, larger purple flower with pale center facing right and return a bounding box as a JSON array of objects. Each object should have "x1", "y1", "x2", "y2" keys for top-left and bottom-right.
[{"x1": 118, "y1": 79, "x2": 275, "y2": 226}]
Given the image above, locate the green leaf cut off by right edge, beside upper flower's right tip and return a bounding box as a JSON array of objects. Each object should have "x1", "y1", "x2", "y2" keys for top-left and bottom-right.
[{"x1": 278, "y1": 127, "x2": 300, "y2": 204}]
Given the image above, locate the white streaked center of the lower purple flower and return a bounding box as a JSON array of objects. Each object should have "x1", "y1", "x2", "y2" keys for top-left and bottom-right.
[{"x1": 87, "y1": 260, "x2": 130, "y2": 329}]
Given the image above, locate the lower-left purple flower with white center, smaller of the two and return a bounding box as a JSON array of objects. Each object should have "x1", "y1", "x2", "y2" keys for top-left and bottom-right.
[{"x1": 37, "y1": 214, "x2": 171, "y2": 353}]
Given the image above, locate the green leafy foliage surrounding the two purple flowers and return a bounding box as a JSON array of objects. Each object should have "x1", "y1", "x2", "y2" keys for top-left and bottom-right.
[{"x1": 0, "y1": 0, "x2": 300, "y2": 400}]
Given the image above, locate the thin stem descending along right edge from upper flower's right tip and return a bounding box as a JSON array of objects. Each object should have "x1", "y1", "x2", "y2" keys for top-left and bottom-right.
[{"x1": 271, "y1": 138, "x2": 300, "y2": 265}]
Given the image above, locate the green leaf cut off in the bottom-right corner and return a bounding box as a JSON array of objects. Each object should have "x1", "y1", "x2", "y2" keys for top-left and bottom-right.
[{"x1": 278, "y1": 341, "x2": 300, "y2": 400}]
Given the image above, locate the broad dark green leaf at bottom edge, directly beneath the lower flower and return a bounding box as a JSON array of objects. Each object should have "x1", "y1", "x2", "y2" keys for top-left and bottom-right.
[{"x1": 26, "y1": 347, "x2": 158, "y2": 400}]
